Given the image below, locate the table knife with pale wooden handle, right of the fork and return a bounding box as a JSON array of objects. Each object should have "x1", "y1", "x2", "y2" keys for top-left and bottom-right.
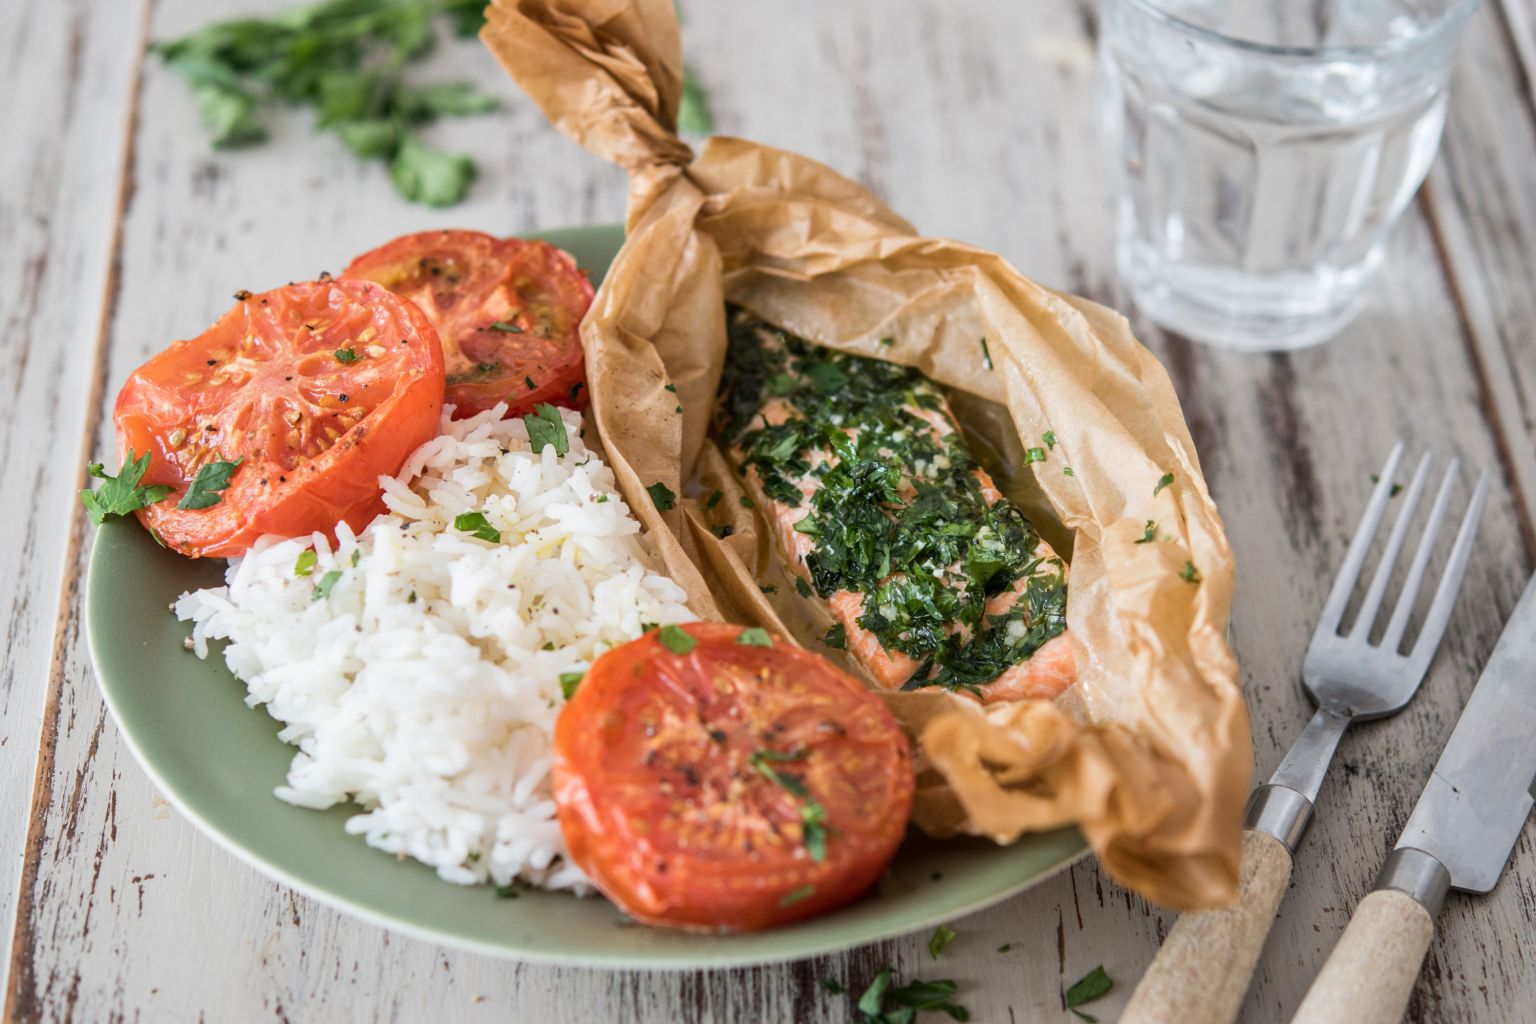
[{"x1": 1295, "y1": 577, "x2": 1536, "y2": 1024}]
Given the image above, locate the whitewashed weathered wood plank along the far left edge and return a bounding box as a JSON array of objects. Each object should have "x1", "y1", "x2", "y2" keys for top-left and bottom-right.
[{"x1": 0, "y1": 0, "x2": 143, "y2": 1000}]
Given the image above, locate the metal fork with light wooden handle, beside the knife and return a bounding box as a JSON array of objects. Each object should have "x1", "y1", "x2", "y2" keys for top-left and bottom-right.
[{"x1": 1120, "y1": 442, "x2": 1488, "y2": 1024}]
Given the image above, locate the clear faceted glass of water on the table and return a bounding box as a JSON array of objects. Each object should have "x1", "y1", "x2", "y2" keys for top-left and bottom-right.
[{"x1": 1098, "y1": 0, "x2": 1479, "y2": 352}]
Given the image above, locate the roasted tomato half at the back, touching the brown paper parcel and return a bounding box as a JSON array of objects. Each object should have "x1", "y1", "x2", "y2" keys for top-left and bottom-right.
[{"x1": 343, "y1": 232, "x2": 591, "y2": 419}]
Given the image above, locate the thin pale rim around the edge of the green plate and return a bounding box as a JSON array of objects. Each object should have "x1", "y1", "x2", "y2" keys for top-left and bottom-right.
[{"x1": 81, "y1": 223, "x2": 1091, "y2": 972}]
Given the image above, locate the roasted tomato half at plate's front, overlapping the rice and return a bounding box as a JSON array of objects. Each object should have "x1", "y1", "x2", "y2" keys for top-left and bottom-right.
[{"x1": 553, "y1": 622, "x2": 914, "y2": 930}]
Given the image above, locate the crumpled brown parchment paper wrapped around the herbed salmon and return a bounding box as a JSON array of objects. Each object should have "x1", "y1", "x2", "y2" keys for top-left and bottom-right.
[{"x1": 482, "y1": 0, "x2": 1250, "y2": 907}]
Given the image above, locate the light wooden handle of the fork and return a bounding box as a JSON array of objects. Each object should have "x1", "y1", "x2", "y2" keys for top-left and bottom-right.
[{"x1": 1120, "y1": 829, "x2": 1290, "y2": 1024}]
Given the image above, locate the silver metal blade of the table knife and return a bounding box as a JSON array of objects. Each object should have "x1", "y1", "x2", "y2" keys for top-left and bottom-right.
[{"x1": 1392, "y1": 577, "x2": 1536, "y2": 892}]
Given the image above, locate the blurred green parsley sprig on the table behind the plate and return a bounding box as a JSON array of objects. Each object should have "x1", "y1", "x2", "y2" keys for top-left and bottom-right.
[{"x1": 154, "y1": 0, "x2": 496, "y2": 206}]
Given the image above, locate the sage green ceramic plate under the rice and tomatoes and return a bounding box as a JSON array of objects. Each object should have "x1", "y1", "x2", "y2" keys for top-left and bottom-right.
[{"x1": 86, "y1": 226, "x2": 1084, "y2": 969}]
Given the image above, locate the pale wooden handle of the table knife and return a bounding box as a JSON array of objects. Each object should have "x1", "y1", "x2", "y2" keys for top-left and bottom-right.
[{"x1": 1293, "y1": 889, "x2": 1435, "y2": 1024}]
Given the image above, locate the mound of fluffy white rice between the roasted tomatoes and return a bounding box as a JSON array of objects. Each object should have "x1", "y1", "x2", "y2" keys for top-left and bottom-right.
[{"x1": 175, "y1": 407, "x2": 694, "y2": 889}]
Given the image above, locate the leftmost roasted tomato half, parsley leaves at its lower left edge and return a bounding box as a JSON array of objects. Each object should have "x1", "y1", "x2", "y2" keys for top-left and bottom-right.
[{"x1": 114, "y1": 279, "x2": 442, "y2": 557}]
